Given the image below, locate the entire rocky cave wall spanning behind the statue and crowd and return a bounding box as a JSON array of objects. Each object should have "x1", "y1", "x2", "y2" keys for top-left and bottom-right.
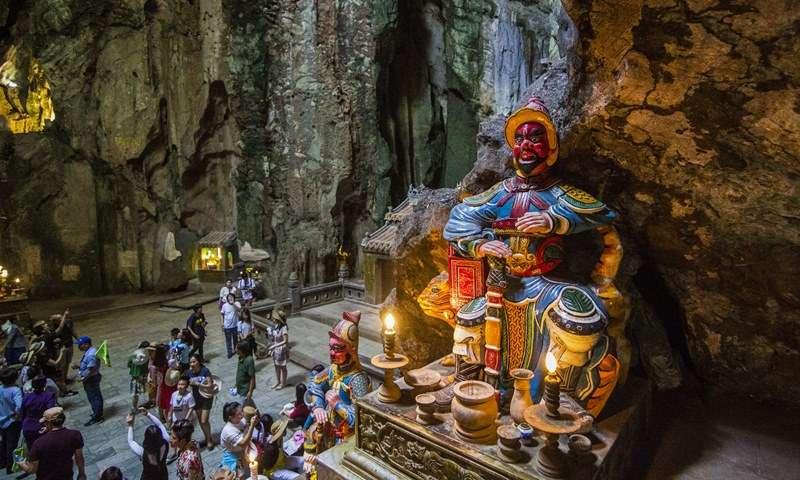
[{"x1": 0, "y1": 0, "x2": 800, "y2": 402}]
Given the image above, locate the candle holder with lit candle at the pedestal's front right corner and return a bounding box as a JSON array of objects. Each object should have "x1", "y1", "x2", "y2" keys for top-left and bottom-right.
[{"x1": 524, "y1": 402, "x2": 591, "y2": 478}]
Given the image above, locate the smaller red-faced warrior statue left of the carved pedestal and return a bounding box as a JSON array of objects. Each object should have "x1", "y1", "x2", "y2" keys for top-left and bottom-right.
[{"x1": 304, "y1": 311, "x2": 372, "y2": 472}]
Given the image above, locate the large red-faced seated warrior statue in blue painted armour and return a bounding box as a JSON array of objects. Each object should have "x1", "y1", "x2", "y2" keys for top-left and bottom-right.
[{"x1": 444, "y1": 97, "x2": 622, "y2": 415}]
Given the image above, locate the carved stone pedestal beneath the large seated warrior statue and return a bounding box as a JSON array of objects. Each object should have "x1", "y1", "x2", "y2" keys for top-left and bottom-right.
[{"x1": 318, "y1": 362, "x2": 651, "y2": 480}]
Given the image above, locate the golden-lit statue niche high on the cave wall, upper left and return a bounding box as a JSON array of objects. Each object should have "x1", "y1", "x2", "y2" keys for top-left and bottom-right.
[{"x1": 0, "y1": 45, "x2": 56, "y2": 133}]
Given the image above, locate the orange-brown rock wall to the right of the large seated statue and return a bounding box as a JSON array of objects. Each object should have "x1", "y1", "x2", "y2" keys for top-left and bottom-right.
[{"x1": 565, "y1": 0, "x2": 800, "y2": 404}]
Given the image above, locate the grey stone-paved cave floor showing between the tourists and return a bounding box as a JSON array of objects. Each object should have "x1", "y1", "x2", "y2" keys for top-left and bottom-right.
[{"x1": 0, "y1": 296, "x2": 307, "y2": 480}]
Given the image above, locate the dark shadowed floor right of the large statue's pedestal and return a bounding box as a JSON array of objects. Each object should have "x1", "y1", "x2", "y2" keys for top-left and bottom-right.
[{"x1": 636, "y1": 382, "x2": 800, "y2": 480}]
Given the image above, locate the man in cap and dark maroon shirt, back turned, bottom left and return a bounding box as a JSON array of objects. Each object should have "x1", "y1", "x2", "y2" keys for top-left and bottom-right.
[{"x1": 19, "y1": 407, "x2": 86, "y2": 480}]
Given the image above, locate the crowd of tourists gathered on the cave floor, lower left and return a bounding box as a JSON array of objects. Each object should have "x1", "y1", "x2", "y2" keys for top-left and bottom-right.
[{"x1": 0, "y1": 274, "x2": 322, "y2": 480}]
